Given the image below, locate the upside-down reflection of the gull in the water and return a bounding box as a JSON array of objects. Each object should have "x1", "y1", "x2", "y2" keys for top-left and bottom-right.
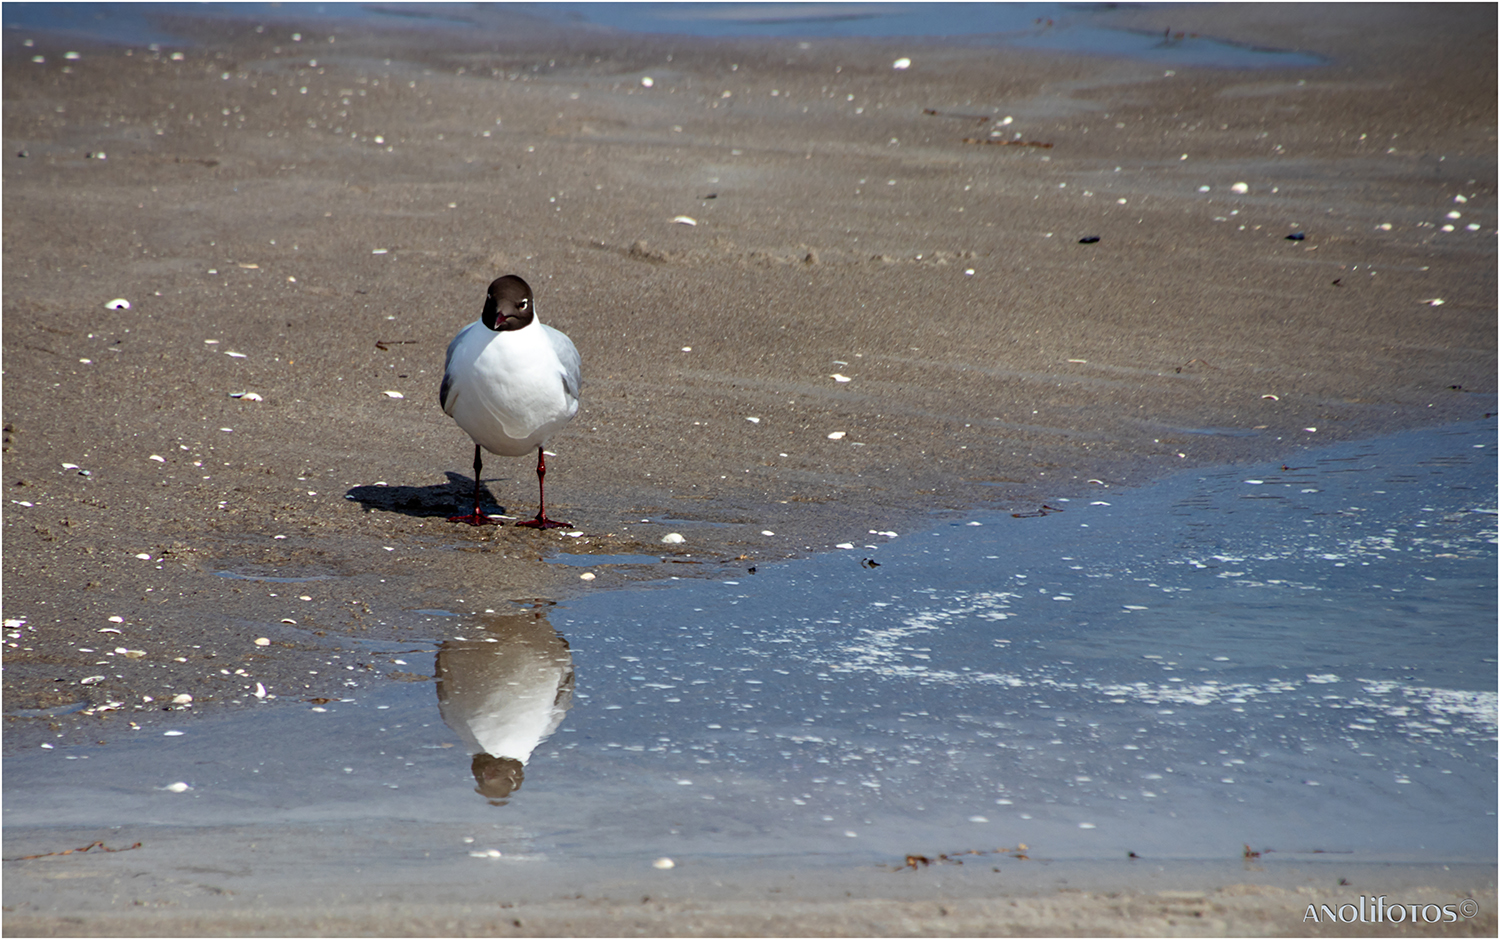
[{"x1": 437, "y1": 610, "x2": 573, "y2": 802}]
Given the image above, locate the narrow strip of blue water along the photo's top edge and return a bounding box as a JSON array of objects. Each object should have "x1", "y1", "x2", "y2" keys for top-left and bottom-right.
[{"x1": 3, "y1": 3, "x2": 1326, "y2": 69}]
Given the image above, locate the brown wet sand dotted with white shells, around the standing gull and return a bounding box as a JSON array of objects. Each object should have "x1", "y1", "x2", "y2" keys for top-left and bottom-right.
[{"x1": 0, "y1": 6, "x2": 1496, "y2": 933}]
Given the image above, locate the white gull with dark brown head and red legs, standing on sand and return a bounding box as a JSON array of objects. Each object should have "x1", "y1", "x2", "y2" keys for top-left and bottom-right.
[{"x1": 438, "y1": 274, "x2": 582, "y2": 529}]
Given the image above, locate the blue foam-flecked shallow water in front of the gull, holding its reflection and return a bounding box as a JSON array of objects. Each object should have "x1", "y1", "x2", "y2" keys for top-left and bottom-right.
[{"x1": 5, "y1": 423, "x2": 1497, "y2": 881}]
